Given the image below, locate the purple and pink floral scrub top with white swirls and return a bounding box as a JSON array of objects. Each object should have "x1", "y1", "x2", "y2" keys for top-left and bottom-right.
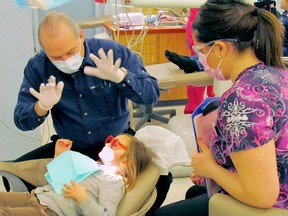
[{"x1": 211, "y1": 63, "x2": 288, "y2": 209}]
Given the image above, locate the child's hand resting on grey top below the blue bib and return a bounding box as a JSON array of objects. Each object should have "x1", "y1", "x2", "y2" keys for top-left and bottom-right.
[{"x1": 62, "y1": 180, "x2": 88, "y2": 204}]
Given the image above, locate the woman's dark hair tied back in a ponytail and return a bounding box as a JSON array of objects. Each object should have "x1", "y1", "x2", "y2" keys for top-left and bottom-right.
[{"x1": 192, "y1": 0, "x2": 285, "y2": 68}]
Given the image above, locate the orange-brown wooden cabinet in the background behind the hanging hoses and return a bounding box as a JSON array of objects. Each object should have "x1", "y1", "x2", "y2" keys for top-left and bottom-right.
[{"x1": 104, "y1": 21, "x2": 190, "y2": 101}]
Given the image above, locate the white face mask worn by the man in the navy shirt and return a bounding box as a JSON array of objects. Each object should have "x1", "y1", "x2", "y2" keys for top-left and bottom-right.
[{"x1": 51, "y1": 42, "x2": 84, "y2": 74}]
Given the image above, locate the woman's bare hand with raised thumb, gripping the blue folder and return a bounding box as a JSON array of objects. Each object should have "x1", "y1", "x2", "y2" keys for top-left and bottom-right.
[{"x1": 192, "y1": 138, "x2": 219, "y2": 178}]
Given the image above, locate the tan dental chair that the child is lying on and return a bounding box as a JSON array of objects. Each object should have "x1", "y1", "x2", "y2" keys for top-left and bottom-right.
[{"x1": 0, "y1": 159, "x2": 160, "y2": 216}]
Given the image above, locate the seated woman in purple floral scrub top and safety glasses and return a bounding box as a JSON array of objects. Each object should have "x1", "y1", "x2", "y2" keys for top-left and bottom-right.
[{"x1": 149, "y1": 0, "x2": 288, "y2": 216}]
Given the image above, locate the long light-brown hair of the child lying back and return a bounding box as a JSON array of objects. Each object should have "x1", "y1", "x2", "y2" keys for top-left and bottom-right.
[{"x1": 119, "y1": 134, "x2": 154, "y2": 190}]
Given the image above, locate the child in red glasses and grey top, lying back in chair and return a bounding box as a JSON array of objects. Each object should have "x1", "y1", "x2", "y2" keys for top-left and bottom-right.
[{"x1": 0, "y1": 134, "x2": 154, "y2": 216}]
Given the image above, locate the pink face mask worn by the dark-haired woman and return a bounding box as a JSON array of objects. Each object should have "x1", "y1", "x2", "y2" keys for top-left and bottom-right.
[{"x1": 194, "y1": 41, "x2": 228, "y2": 80}]
